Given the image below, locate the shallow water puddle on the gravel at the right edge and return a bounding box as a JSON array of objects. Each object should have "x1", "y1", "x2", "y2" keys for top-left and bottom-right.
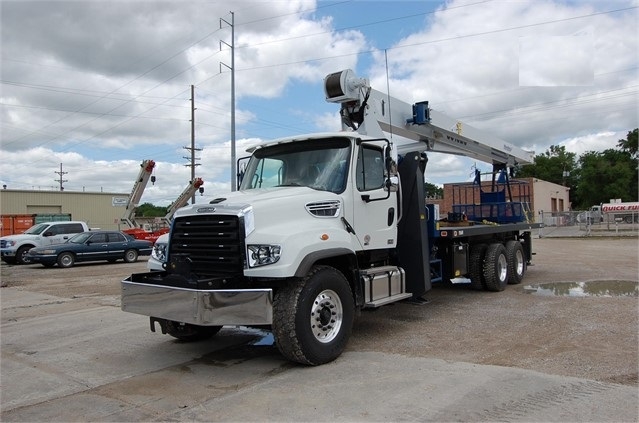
[{"x1": 524, "y1": 281, "x2": 639, "y2": 297}]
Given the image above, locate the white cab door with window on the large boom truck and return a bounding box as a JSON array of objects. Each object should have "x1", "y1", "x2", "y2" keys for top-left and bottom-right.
[{"x1": 351, "y1": 142, "x2": 397, "y2": 250}]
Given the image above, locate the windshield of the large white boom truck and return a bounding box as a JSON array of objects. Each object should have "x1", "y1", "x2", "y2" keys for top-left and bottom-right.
[{"x1": 240, "y1": 138, "x2": 351, "y2": 193}]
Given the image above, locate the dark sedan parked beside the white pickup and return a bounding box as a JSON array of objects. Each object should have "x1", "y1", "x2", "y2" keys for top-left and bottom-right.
[{"x1": 27, "y1": 231, "x2": 153, "y2": 267}]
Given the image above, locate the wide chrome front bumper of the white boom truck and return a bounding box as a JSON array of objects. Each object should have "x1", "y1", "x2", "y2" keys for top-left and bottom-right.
[{"x1": 121, "y1": 278, "x2": 273, "y2": 326}]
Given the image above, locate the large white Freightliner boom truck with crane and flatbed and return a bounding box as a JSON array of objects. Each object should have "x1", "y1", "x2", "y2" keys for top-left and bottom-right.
[{"x1": 122, "y1": 70, "x2": 539, "y2": 365}]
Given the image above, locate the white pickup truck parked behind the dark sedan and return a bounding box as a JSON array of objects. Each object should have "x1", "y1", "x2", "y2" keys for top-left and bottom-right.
[{"x1": 0, "y1": 221, "x2": 89, "y2": 264}]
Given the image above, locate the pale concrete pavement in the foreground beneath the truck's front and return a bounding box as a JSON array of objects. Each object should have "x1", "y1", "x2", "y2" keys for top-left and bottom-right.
[{"x1": 0, "y1": 288, "x2": 639, "y2": 421}]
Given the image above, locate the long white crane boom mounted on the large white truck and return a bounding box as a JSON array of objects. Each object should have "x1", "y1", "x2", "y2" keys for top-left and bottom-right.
[{"x1": 324, "y1": 69, "x2": 534, "y2": 166}]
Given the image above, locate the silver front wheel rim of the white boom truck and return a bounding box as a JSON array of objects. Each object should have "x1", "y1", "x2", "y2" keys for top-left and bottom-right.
[{"x1": 310, "y1": 289, "x2": 344, "y2": 344}]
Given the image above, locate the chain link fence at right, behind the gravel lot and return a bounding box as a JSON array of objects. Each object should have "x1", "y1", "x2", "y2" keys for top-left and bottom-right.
[{"x1": 537, "y1": 211, "x2": 639, "y2": 238}]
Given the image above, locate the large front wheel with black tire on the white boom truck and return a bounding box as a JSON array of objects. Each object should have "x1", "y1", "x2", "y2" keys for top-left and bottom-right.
[{"x1": 273, "y1": 266, "x2": 355, "y2": 366}]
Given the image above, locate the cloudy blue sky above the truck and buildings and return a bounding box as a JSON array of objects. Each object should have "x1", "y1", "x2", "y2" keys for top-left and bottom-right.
[{"x1": 0, "y1": 0, "x2": 639, "y2": 206}]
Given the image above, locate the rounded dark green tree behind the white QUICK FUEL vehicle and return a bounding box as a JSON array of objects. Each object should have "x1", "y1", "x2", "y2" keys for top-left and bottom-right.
[{"x1": 573, "y1": 149, "x2": 638, "y2": 209}]
